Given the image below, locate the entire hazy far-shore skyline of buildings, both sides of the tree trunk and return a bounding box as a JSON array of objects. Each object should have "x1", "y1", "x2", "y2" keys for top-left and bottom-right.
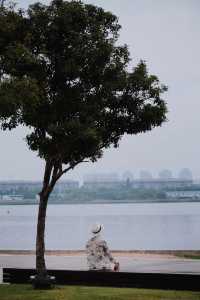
[{"x1": 0, "y1": 168, "x2": 200, "y2": 203}]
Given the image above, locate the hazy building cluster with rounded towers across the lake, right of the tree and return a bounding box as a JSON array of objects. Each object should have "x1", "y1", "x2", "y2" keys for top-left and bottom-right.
[{"x1": 83, "y1": 168, "x2": 200, "y2": 199}]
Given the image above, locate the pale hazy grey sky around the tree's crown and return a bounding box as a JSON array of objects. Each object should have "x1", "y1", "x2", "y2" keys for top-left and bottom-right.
[{"x1": 0, "y1": 0, "x2": 200, "y2": 180}]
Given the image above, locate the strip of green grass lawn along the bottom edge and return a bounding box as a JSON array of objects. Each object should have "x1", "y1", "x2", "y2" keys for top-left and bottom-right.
[{"x1": 0, "y1": 285, "x2": 200, "y2": 300}]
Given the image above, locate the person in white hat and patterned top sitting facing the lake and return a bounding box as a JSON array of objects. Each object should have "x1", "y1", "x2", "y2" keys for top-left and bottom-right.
[{"x1": 86, "y1": 224, "x2": 119, "y2": 271}]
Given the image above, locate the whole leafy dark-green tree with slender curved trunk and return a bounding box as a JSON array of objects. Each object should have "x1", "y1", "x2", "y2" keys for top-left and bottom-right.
[{"x1": 0, "y1": 0, "x2": 166, "y2": 284}]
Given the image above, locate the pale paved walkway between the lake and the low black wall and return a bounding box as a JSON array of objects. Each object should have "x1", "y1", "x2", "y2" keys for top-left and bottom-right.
[{"x1": 0, "y1": 254, "x2": 200, "y2": 281}]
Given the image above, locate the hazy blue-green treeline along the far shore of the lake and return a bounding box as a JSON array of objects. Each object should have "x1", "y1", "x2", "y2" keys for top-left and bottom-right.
[{"x1": 0, "y1": 185, "x2": 200, "y2": 204}]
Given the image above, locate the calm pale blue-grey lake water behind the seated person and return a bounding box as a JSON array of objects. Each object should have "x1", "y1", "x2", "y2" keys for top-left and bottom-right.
[{"x1": 0, "y1": 203, "x2": 200, "y2": 250}]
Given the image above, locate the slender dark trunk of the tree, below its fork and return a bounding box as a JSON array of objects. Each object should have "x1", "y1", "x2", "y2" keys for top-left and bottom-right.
[{"x1": 36, "y1": 194, "x2": 48, "y2": 278}]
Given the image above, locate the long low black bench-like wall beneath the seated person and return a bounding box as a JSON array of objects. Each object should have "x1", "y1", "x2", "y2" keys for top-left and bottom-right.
[{"x1": 3, "y1": 268, "x2": 200, "y2": 291}]
